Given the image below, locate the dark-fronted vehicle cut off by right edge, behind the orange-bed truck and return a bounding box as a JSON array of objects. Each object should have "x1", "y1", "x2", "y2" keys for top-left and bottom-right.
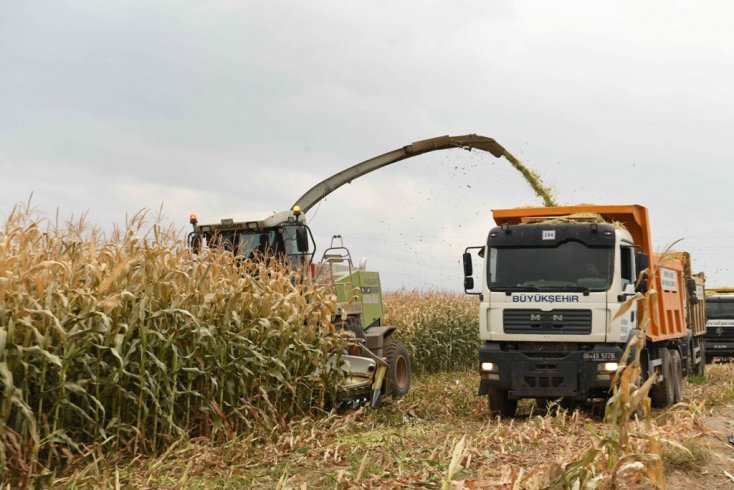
[{"x1": 705, "y1": 287, "x2": 734, "y2": 362}]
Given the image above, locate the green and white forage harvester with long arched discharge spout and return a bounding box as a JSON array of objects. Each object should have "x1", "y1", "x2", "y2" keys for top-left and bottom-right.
[{"x1": 188, "y1": 134, "x2": 514, "y2": 406}]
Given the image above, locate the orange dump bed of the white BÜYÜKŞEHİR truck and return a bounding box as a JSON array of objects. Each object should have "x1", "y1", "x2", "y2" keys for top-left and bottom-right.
[{"x1": 492, "y1": 204, "x2": 686, "y2": 341}]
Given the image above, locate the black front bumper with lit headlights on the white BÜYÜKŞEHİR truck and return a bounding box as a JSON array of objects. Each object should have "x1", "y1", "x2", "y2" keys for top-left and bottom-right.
[{"x1": 479, "y1": 344, "x2": 623, "y2": 400}]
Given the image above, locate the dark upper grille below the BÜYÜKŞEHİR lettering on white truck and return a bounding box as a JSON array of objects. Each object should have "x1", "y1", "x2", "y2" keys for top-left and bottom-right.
[{"x1": 503, "y1": 310, "x2": 591, "y2": 335}]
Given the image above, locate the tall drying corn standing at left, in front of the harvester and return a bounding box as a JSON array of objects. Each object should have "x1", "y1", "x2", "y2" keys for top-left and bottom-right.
[{"x1": 0, "y1": 208, "x2": 343, "y2": 485}]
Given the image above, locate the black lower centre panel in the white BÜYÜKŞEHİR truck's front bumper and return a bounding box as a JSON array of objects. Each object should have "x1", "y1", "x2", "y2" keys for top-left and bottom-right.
[{"x1": 509, "y1": 360, "x2": 579, "y2": 398}]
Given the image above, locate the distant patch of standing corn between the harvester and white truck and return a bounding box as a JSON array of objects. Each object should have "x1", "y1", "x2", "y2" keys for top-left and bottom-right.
[{"x1": 384, "y1": 290, "x2": 479, "y2": 373}]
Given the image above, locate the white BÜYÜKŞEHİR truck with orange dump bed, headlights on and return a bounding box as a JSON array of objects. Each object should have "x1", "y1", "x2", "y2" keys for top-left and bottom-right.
[{"x1": 463, "y1": 205, "x2": 705, "y2": 416}]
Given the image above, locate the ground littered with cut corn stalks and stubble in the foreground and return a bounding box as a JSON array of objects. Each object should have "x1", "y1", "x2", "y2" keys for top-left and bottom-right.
[{"x1": 56, "y1": 364, "x2": 734, "y2": 490}]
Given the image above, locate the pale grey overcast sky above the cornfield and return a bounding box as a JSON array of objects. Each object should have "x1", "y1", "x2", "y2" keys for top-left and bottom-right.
[{"x1": 0, "y1": 0, "x2": 734, "y2": 290}]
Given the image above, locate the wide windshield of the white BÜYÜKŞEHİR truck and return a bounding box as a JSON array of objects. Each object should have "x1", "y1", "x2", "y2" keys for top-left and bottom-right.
[{"x1": 487, "y1": 241, "x2": 614, "y2": 291}]
